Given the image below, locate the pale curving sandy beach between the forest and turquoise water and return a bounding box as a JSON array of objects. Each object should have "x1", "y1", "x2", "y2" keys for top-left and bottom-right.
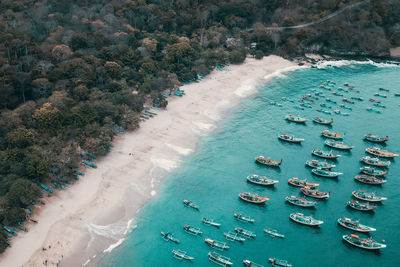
[{"x1": 0, "y1": 56, "x2": 298, "y2": 266}]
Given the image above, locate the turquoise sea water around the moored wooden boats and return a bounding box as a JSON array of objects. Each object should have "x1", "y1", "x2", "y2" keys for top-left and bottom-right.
[{"x1": 98, "y1": 62, "x2": 400, "y2": 266}]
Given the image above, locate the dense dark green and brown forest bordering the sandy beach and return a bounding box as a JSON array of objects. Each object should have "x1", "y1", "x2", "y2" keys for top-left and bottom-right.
[{"x1": 0, "y1": 0, "x2": 400, "y2": 252}]
